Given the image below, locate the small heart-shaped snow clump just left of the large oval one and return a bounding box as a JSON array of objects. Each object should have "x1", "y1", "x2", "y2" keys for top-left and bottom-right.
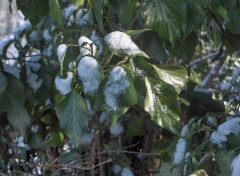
[{"x1": 55, "y1": 72, "x2": 73, "y2": 95}]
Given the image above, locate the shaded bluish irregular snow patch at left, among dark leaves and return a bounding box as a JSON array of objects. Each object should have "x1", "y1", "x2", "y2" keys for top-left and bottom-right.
[{"x1": 25, "y1": 62, "x2": 43, "y2": 92}]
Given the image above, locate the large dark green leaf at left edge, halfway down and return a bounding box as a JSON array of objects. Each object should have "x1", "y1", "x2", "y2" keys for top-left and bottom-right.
[{"x1": 0, "y1": 72, "x2": 25, "y2": 112}]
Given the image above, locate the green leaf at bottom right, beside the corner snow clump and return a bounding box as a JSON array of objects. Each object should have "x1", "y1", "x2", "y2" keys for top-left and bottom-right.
[{"x1": 215, "y1": 151, "x2": 236, "y2": 175}]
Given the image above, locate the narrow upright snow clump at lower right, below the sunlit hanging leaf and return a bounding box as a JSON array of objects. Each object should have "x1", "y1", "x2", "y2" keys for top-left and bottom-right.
[{"x1": 173, "y1": 138, "x2": 187, "y2": 165}]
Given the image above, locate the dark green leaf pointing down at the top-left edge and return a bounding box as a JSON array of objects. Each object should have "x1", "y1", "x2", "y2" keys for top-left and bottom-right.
[{"x1": 17, "y1": 0, "x2": 49, "y2": 25}]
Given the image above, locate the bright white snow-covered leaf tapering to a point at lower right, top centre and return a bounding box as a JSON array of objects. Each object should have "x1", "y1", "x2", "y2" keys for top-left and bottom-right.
[{"x1": 104, "y1": 31, "x2": 149, "y2": 58}]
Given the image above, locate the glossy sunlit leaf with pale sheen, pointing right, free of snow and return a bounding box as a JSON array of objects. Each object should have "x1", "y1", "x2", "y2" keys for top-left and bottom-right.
[{"x1": 153, "y1": 65, "x2": 188, "y2": 93}]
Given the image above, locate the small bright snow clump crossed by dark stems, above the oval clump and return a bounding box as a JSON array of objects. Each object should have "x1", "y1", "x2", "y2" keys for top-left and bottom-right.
[{"x1": 78, "y1": 36, "x2": 97, "y2": 57}]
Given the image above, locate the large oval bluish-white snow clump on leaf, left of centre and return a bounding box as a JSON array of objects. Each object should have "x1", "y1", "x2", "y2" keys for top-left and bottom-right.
[{"x1": 78, "y1": 56, "x2": 101, "y2": 95}]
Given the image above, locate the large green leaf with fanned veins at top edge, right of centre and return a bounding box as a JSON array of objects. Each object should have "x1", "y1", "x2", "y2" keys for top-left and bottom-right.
[{"x1": 144, "y1": 0, "x2": 187, "y2": 44}]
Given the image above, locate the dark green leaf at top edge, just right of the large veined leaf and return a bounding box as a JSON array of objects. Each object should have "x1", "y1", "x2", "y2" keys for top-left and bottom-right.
[{"x1": 182, "y1": 0, "x2": 205, "y2": 38}]
